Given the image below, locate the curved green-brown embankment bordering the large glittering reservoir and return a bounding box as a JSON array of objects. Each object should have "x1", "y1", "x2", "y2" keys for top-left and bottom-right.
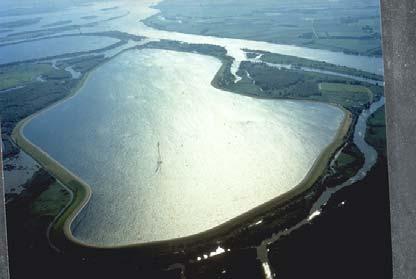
[{"x1": 12, "y1": 48, "x2": 352, "y2": 255}]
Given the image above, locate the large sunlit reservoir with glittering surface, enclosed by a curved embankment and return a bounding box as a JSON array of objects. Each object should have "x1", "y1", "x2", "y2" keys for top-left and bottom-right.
[{"x1": 24, "y1": 50, "x2": 344, "y2": 245}]
